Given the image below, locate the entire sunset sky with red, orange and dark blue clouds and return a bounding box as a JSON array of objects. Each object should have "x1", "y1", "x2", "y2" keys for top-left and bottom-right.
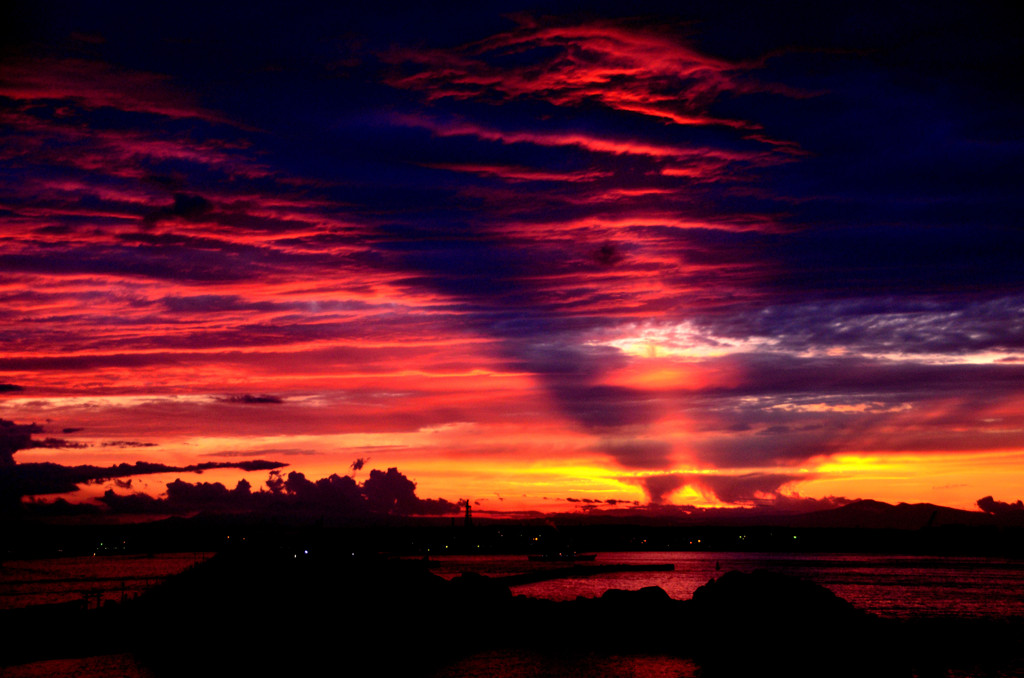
[{"x1": 0, "y1": 2, "x2": 1024, "y2": 515}]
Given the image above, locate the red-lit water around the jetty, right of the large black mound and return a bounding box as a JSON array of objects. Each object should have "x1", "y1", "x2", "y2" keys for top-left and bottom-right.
[{"x1": 423, "y1": 552, "x2": 1024, "y2": 618}]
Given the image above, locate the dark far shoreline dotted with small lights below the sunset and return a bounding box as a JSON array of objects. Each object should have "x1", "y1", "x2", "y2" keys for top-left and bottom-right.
[{"x1": 8, "y1": 515, "x2": 1024, "y2": 566}]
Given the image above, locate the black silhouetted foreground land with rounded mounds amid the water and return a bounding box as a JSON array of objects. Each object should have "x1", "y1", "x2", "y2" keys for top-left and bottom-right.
[{"x1": 0, "y1": 548, "x2": 1024, "y2": 677}]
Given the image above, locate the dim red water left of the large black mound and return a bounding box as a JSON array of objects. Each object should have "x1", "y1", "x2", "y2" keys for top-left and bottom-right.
[{"x1": 0, "y1": 553, "x2": 212, "y2": 609}]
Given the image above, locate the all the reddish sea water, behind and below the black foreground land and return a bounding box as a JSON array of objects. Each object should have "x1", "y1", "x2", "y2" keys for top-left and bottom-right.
[{"x1": 0, "y1": 552, "x2": 1024, "y2": 678}]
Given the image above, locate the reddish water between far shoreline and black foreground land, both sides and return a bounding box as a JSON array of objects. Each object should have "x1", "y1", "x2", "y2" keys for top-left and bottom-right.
[{"x1": 6, "y1": 552, "x2": 1024, "y2": 619}]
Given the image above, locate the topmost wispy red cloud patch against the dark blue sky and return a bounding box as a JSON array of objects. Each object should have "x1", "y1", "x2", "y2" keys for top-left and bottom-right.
[{"x1": 390, "y1": 20, "x2": 757, "y2": 128}]
